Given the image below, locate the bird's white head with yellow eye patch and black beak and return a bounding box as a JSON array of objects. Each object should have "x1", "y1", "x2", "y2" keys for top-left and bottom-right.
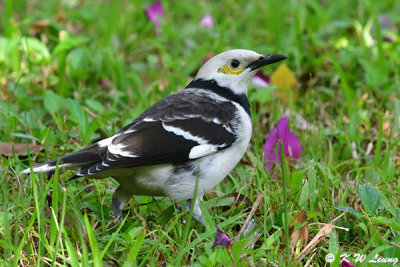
[{"x1": 194, "y1": 49, "x2": 287, "y2": 94}]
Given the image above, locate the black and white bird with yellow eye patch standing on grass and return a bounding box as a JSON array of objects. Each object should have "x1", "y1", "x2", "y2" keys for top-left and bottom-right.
[{"x1": 22, "y1": 49, "x2": 287, "y2": 225}]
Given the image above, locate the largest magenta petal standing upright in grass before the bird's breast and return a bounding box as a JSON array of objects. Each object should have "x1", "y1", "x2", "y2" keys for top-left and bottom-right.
[{"x1": 264, "y1": 116, "x2": 303, "y2": 170}]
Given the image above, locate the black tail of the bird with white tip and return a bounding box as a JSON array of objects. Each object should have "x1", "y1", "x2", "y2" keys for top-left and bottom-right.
[{"x1": 21, "y1": 144, "x2": 104, "y2": 173}]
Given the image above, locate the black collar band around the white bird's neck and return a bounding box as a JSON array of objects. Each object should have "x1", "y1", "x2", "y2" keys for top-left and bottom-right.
[{"x1": 186, "y1": 79, "x2": 251, "y2": 117}]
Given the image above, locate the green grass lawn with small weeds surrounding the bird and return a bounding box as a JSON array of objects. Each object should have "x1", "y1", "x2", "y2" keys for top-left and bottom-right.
[{"x1": 0, "y1": 0, "x2": 400, "y2": 266}]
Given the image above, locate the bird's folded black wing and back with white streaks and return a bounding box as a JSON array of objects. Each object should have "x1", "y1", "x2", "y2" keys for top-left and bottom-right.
[{"x1": 78, "y1": 89, "x2": 238, "y2": 175}]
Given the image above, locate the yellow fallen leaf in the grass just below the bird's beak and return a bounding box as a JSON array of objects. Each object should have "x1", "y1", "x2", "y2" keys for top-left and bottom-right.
[{"x1": 271, "y1": 63, "x2": 299, "y2": 104}]
